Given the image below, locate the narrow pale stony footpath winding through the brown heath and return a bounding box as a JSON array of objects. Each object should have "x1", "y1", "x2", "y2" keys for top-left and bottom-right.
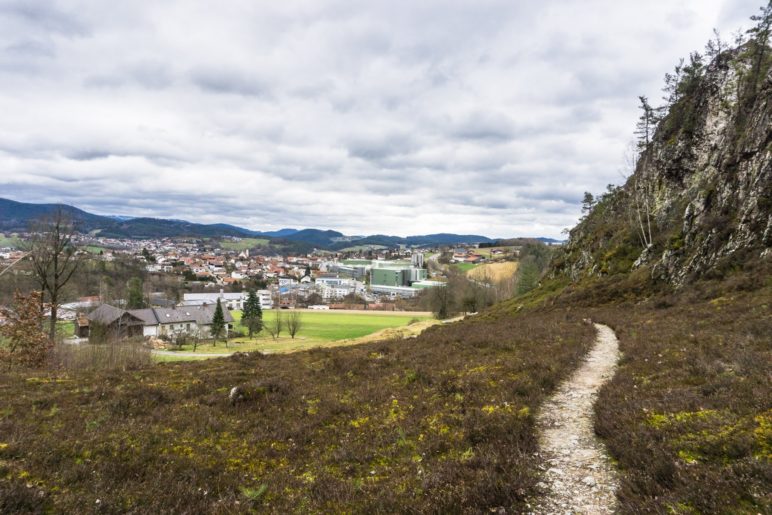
[{"x1": 533, "y1": 324, "x2": 619, "y2": 514}]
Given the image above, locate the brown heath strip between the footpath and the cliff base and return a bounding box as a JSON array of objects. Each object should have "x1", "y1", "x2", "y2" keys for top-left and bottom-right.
[{"x1": 489, "y1": 260, "x2": 772, "y2": 514}]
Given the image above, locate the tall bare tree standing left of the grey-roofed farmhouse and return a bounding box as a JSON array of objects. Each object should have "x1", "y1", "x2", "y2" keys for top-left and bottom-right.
[{"x1": 26, "y1": 210, "x2": 80, "y2": 342}]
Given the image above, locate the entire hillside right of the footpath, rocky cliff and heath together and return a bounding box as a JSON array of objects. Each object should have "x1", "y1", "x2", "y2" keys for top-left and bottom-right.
[{"x1": 532, "y1": 41, "x2": 772, "y2": 514}]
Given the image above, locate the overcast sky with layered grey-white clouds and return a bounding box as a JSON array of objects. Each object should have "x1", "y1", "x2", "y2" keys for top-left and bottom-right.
[{"x1": 0, "y1": 0, "x2": 762, "y2": 237}]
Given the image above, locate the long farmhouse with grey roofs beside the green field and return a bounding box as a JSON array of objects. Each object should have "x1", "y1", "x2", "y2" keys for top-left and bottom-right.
[{"x1": 88, "y1": 304, "x2": 234, "y2": 339}]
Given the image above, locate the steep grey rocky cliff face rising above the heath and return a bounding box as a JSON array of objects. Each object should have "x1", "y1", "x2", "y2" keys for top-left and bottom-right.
[{"x1": 552, "y1": 42, "x2": 772, "y2": 287}]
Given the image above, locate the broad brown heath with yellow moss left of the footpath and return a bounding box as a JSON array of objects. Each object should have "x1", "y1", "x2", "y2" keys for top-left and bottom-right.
[{"x1": 0, "y1": 312, "x2": 594, "y2": 513}]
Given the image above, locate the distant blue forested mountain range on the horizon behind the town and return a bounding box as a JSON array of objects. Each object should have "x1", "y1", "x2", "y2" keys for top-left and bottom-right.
[{"x1": 0, "y1": 198, "x2": 556, "y2": 250}]
